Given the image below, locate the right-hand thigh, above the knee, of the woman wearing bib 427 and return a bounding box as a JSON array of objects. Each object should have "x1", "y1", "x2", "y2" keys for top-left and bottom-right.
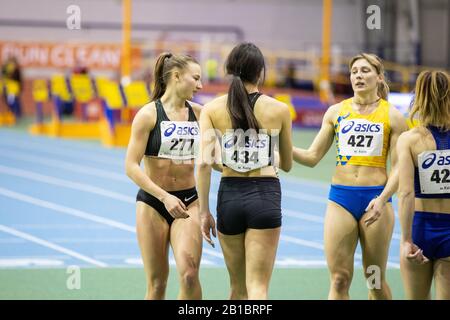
[{"x1": 359, "y1": 203, "x2": 394, "y2": 274}]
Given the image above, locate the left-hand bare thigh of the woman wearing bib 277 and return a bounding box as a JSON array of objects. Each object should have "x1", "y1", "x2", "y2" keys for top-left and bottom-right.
[{"x1": 136, "y1": 201, "x2": 169, "y2": 274}]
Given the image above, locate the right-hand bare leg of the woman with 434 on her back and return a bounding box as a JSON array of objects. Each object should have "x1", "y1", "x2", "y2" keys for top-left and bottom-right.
[{"x1": 245, "y1": 227, "x2": 281, "y2": 300}]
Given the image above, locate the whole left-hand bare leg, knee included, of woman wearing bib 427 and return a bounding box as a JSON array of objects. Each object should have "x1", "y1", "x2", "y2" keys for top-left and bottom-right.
[{"x1": 324, "y1": 201, "x2": 358, "y2": 299}]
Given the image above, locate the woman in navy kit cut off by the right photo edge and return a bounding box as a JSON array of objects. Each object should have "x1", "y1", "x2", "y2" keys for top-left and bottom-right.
[{"x1": 397, "y1": 71, "x2": 450, "y2": 300}]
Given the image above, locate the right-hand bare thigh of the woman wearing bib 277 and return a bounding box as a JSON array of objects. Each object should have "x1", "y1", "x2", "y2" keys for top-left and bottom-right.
[{"x1": 170, "y1": 200, "x2": 202, "y2": 269}]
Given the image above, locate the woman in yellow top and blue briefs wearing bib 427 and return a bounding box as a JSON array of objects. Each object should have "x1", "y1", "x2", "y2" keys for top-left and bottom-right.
[{"x1": 294, "y1": 54, "x2": 407, "y2": 299}]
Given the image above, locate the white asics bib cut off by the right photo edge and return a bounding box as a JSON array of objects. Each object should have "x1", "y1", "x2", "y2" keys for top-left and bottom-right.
[{"x1": 417, "y1": 150, "x2": 450, "y2": 194}]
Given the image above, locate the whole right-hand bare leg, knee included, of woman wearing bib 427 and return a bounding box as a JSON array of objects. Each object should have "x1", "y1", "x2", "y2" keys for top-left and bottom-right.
[{"x1": 359, "y1": 203, "x2": 394, "y2": 300}]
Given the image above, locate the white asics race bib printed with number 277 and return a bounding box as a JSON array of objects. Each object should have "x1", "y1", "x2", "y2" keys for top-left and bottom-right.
[{"x1": 158, "y1": 121, "x2": 200, "y2": 160}]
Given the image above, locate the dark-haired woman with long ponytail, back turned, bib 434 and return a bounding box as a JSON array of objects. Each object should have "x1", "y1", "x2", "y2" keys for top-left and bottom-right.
[{"x1": 198, "y1": 43, "x2": 292, "y2": 299}]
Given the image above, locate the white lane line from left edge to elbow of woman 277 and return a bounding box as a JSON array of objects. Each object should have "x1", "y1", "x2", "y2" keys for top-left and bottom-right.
[{"x1": 0, "y1": 148, "x2": 128, "y2": 183}]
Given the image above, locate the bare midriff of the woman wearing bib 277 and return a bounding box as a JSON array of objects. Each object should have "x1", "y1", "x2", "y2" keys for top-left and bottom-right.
[{"x1": 143, "y1": 157, "x2": 195, "y2": 191}]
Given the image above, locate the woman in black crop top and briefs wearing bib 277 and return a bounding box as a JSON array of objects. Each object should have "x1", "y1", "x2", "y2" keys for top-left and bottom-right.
[{"x1": 126, "y1": 53, "x2": 202, "y2": 299}]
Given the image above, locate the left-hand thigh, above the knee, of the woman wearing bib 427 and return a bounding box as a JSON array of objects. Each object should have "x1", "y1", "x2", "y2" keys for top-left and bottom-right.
[{"x1": 324, "y1": 201, "x2": 359, "y2": 273}]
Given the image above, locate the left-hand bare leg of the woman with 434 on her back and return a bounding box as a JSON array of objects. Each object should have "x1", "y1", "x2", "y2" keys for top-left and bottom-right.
[{"x1": 219, "y1": 232, "x2": 247, "y2": 300}]
